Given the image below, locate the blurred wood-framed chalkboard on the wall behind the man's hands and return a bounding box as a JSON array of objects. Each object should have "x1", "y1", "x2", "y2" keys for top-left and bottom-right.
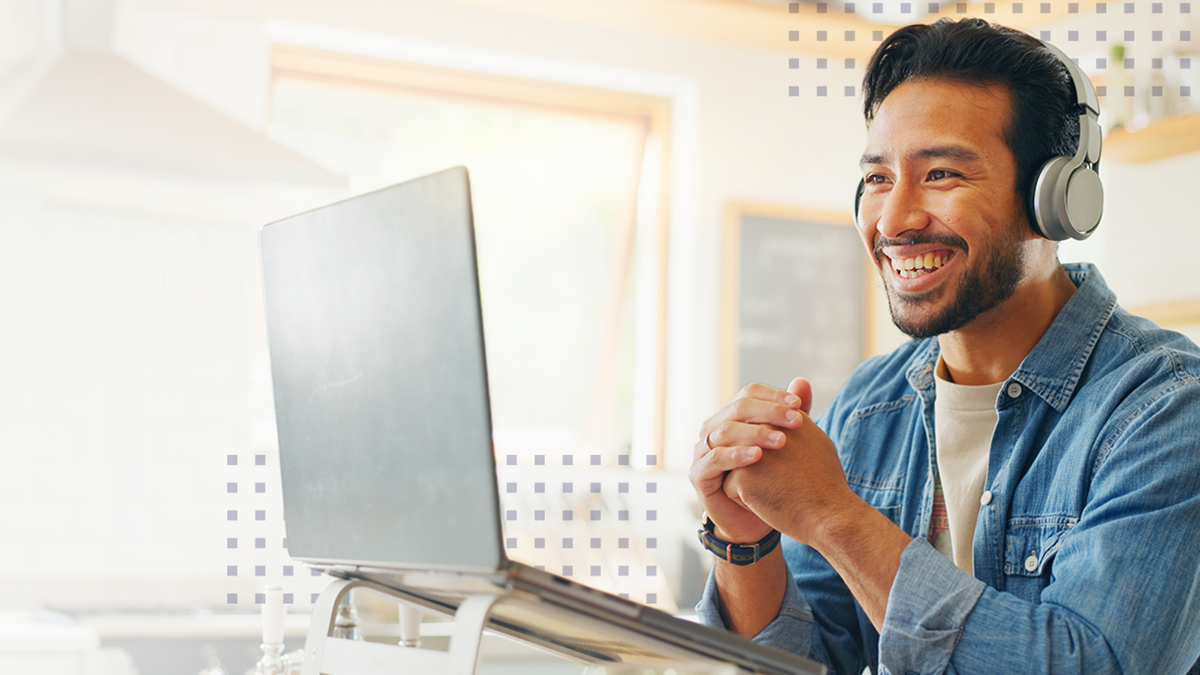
[{"x1": 722, "y1": 201, "x2": 868, "y2": 417}]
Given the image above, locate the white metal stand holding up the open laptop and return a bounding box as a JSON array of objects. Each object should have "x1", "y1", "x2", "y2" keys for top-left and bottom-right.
[{"x1": 300, "y1": 579, "x2": 500, "y2": 675}]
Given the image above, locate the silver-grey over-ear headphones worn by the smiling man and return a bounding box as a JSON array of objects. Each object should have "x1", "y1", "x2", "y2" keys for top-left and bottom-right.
[{"x1": 854, "y1": 42, "x2": 1104, "y2": 241}]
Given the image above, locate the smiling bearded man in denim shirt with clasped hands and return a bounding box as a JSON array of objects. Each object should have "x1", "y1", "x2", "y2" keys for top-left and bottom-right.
[{"x1": 690, "y1": 19, "x2": 1200, "y2": 674}]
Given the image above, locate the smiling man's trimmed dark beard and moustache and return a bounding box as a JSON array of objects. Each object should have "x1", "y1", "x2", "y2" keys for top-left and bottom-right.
[{"x1": 875, "y1": 228, "x2": 1025, "y2": 338}]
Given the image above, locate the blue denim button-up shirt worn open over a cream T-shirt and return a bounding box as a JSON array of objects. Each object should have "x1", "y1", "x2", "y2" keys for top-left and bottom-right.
[{"x1": 696, "y1": 265, "x2": 1200, "y2": 675}]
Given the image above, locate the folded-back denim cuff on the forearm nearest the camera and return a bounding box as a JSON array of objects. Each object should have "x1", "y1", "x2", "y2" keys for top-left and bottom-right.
[{"x1": 880, "y1": 537, "x2": 986, "y2": 673}]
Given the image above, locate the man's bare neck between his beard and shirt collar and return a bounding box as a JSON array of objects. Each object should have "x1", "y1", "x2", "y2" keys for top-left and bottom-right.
[{"x1": 937, "y1": 261, "x2": 1075, "y2": 386}]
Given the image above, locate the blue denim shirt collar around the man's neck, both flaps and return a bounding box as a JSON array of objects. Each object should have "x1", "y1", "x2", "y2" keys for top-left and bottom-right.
[{"x1": 906, "y1": 263, "x2": 1117, "y2": 412}]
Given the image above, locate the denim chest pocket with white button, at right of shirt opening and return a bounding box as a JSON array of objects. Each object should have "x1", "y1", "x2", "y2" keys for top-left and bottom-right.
[{"x1": 1004, "y1": 518, "x2": 1076, "y2": 595}]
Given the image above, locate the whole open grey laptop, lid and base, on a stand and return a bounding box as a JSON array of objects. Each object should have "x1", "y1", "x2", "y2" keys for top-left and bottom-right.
[{"x1": 259, "y1": 167, "x2": 824, "y2": 675}]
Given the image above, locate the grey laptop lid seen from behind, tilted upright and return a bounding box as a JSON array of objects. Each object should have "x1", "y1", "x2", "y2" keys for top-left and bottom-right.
[{"x1": 260, "y1": 167, "x2": 506, "y2": 573}]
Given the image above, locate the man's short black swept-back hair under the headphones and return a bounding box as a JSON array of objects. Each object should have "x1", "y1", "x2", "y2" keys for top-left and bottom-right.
[{"x1": 863, "y1": 18, "x2": 1079, "y2": 222}]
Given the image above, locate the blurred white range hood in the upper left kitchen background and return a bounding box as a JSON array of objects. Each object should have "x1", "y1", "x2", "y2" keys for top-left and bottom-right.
[{"x1": 0, "y1": 0, "x2": 346, "y2": 187}]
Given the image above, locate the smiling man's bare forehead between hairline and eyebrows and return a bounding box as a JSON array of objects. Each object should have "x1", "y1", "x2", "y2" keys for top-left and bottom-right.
[{"x1": 864, "y1": 79, "x2": 1013, "y2": 159}]
